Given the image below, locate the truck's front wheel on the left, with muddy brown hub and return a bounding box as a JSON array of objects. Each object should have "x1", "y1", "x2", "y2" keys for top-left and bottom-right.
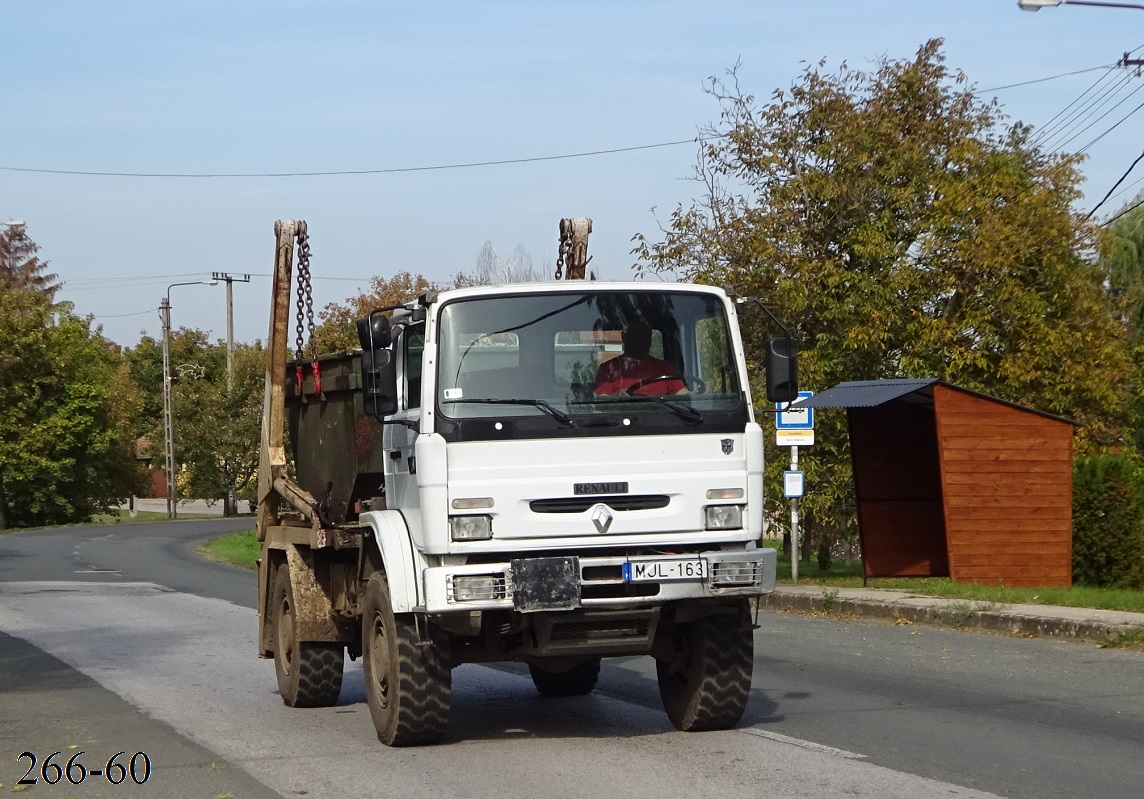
[{"x1": 362, "y1": 573, "x2": 453, "y2": 746}]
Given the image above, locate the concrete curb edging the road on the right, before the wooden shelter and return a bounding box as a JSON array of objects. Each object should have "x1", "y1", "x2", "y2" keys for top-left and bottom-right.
[{"x1": 760, "y1": 590, "x2": 1134, "y2": 643}]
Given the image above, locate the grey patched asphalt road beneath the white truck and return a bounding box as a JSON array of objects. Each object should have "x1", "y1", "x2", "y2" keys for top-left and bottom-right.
[{"x1": 0, "y1": 520, "x2": 1144, "y2": 799}]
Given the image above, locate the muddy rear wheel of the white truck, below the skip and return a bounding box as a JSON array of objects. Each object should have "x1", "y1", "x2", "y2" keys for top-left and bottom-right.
[{"x1": 270, "y1": 565, "x2": 345, "y2": 707}]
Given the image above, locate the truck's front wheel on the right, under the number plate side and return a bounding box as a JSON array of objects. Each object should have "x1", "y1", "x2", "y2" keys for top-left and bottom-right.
[{"x1": 656, "y1": 603, "x2": 755, "y2": 733}]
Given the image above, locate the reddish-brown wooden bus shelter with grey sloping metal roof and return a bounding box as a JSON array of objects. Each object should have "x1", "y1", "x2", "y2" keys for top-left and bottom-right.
[{"x1": 799, "y1": 379, "x2": 1075, "y2": 586}]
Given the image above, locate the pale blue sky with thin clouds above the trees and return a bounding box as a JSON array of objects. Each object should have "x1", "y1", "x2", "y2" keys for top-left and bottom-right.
[{"x1": 0, "y1": 0, "x2": 1144, "y2": 346}]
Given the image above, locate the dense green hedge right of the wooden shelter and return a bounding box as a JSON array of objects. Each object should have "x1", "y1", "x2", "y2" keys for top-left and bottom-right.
[{"x1": 1073, "y1": 453, "x2": 1144, "y2": 588}]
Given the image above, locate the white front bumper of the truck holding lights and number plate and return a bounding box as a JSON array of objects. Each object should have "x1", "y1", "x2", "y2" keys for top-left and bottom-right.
[{"x1": 423, "y1": 549, "x2": 778, "y2": 614}]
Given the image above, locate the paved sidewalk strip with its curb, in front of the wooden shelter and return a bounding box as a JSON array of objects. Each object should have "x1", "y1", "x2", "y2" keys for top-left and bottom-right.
[{"x1": 762, "y1": 585, "x2": 1144, "y2": 642}]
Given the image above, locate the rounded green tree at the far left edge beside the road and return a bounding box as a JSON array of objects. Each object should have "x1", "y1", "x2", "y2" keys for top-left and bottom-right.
[{"x1": 0, "y1": 284, "x2": 143, "y2": 528}]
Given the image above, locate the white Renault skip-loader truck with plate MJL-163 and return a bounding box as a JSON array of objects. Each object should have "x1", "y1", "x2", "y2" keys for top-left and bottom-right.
[{"x1": 259, "y1": 221, "x2": 797, "y2": 746}]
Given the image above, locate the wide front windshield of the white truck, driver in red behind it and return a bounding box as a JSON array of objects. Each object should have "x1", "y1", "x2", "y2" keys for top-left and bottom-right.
[{"x1": 437, "y1": 290, "x2": 742, "y2": 425}]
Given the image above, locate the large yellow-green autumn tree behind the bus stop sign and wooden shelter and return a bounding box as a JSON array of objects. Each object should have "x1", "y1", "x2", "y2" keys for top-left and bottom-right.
[{"x1": 634, "y1": 40, "x2": 1134, "y2": 551}]
